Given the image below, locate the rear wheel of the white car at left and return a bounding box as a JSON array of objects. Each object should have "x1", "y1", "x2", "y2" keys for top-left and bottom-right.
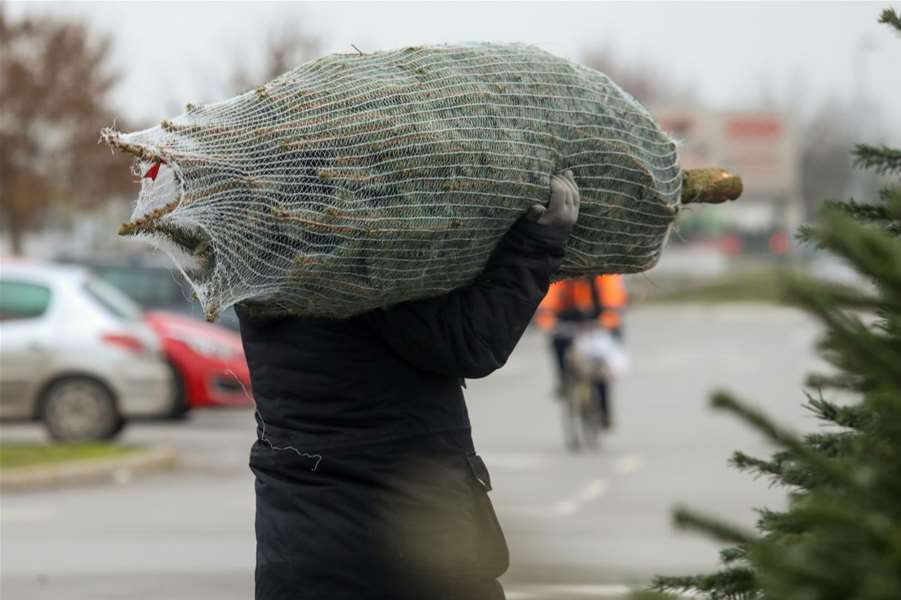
[{"x1": 41, "y1": 377, "x2": 125, "y2": 442}]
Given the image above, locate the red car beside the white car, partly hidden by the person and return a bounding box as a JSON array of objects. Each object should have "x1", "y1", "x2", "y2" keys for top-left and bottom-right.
[{"x1": 145, "y1": 311, "x2": 253, "y2": 417}]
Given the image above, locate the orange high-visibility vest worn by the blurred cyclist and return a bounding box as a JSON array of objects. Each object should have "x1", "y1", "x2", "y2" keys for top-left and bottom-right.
[{"x1": 535, "y1": 275, "x2": 628, "y2": 331}]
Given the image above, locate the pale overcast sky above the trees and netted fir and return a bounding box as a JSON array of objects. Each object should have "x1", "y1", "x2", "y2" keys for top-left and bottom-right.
[{"x1": 8, "y1": 1, "x2": 901, "y2": 141}]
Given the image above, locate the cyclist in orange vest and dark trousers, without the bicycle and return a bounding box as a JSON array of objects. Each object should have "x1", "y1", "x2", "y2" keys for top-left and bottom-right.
[{"x1": 535, "y1": 275, "x2": 628, "y2": 429}]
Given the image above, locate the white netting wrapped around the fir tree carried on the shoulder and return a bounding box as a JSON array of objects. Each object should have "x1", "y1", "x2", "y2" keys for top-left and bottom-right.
[{"x1": 104, "y1": 44, "x2": 681, "y2": 318}]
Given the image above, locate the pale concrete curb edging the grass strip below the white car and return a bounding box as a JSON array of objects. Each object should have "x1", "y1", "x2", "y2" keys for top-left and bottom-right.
[{"x1": 0, "y1": 448, "x2": 178, "y2": 493}]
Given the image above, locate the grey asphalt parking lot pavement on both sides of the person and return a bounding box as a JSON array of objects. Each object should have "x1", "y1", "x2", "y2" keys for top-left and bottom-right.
[{"x1": 0, "y1": 305, "x2": 821, "y2": 600}]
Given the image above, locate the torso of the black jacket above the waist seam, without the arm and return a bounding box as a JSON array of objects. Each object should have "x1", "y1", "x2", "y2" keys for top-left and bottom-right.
[{"x1": 239, "y1": 311, "x2": 469, "y2": 450}]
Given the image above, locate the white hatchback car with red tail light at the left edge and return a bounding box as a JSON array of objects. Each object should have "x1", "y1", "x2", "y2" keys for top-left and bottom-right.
[{"x1": 0, "y1": 261, "x2": 174, "y2": 441}]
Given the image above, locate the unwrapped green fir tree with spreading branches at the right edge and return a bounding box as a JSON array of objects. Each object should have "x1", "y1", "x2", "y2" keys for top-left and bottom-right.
[{"x1": 642, "y1": 9, "x2": 901, "y2": 600}]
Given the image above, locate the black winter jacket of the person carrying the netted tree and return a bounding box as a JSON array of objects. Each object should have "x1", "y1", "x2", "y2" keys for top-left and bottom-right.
[{"x1": 237, "y1": 220, "x2": 569, "y2": 600}]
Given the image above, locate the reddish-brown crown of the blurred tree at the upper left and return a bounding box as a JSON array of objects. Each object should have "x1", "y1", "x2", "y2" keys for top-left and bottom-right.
[{"x1": 0, "y1": 4, "x2": 131, "y2": 254}]
